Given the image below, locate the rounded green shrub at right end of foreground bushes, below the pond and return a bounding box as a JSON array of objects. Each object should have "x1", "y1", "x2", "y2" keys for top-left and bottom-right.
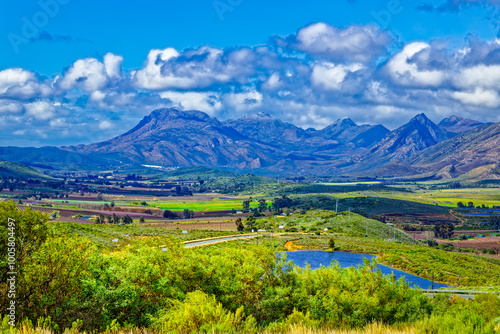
[{"x1": 299, "y1": 260, "x2": 431, "y2": 327}]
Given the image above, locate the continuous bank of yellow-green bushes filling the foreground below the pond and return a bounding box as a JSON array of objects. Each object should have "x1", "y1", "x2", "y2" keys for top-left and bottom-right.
[{"x1": 2, "y1": 232, "x2": 430, "y2": 332}]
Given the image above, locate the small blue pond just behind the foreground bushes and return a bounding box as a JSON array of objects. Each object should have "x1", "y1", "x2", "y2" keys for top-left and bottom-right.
[{"x1": 287, "y1": 251, "x2": 449, "y2": 289}]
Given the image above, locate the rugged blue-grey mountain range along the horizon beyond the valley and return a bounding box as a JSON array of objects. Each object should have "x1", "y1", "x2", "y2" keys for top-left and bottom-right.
[{"x1": 0, "y1": 108, "x2": 494, "y2": 177}]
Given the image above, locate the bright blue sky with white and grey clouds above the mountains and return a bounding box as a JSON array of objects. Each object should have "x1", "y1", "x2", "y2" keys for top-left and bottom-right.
[{"x1": 0, "y1": 0, "x2": 500, "y2": 146}]
